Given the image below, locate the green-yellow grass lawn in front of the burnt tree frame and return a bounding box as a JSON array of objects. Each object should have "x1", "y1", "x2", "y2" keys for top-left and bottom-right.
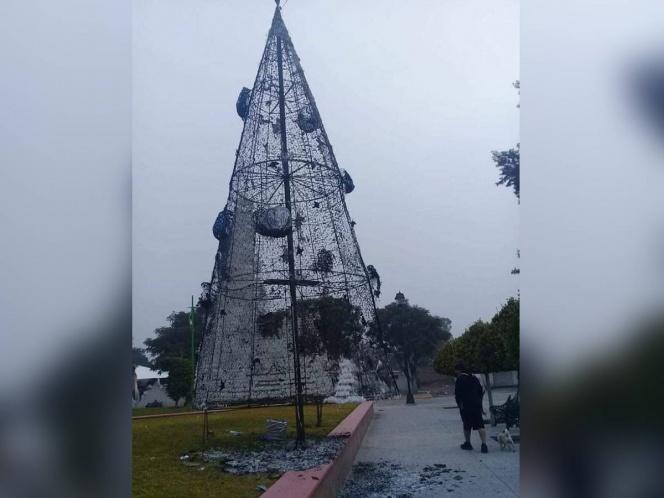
[{"x1": 132, "y1": 404, "x2": 357, "y2": 498}]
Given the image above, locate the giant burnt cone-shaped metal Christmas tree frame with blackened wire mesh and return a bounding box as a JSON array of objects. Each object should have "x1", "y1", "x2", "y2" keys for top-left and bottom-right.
[{"x1": 195, "y1": 4, "x2": 385, "y2": 444}]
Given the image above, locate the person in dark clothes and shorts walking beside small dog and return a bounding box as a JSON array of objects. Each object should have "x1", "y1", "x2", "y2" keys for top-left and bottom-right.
[{"x1": 454, "y1": 362, "x2": 489, "y2": 453}]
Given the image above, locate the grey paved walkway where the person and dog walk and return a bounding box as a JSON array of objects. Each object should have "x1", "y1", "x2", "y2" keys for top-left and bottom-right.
[{"x1": 344, "y1": 390, "x2": 519, "y2": 498}]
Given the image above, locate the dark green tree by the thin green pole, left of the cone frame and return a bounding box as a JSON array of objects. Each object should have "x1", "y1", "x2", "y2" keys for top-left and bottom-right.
[{"x1": 145, "y1": 306, "x2": 205, "y2": 401}]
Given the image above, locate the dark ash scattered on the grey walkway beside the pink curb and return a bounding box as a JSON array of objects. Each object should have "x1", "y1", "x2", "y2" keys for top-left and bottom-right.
[{"x1": 339, "y1": 461, "x2": 474, "y2": 498}]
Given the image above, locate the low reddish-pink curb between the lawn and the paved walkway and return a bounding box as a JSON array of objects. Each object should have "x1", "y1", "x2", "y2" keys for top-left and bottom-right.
[{"x1": 261, "y1": 401, "x2": 374, "y2": 498}]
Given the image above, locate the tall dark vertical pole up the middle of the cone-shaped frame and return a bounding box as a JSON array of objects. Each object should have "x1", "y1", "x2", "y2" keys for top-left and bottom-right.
[{"x1": 277, "y1": 34, "x2": 305, "y2": 447}]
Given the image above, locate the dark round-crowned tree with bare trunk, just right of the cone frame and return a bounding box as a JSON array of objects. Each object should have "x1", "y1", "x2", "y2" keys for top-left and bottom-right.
[{"x1": 370, "y1": 293, "x2": 451, "y2": 404}]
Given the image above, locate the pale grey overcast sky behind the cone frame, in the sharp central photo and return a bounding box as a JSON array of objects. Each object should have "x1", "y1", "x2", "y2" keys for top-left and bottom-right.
[{"x1": 133, "y1": 0, "x2": 519, "y2": 345}]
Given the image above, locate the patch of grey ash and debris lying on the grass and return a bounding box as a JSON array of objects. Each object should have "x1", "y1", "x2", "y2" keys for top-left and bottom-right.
[{"x1": 180, "y1": 437, "x2": 346, "y2": 474}]
